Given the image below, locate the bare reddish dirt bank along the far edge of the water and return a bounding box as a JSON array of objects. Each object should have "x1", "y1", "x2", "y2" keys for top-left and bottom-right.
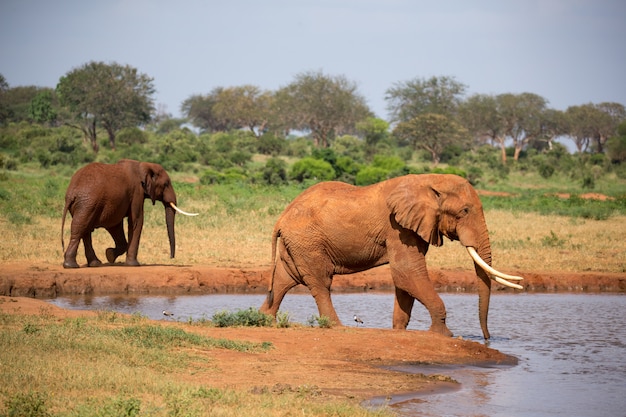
[{"x1": 0, "y1": 263, "x2": 626, "y2": 298}]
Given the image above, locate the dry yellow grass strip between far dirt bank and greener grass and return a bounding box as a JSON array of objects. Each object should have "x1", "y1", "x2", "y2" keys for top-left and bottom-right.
[{"x1": 0, "y1": 205, "x2": 626, "y2": 272}]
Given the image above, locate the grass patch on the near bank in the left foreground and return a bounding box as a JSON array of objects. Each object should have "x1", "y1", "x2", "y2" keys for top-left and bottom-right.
[{"x1": 0, "y1": 306, "x2": 392, "y2": 417}]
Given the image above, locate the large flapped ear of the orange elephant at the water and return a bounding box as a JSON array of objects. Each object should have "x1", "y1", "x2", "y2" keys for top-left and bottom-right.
[{"x1": 387, "y1": 181, "x2": 443, "y2": 246}]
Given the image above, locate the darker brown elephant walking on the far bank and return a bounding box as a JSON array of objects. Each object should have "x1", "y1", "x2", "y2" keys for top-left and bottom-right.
[{"x1": 61, "y1": 159, "x2": 197, "y2": 268}]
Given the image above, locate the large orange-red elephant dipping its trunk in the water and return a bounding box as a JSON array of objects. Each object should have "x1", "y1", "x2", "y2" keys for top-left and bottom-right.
[{"x1": 260, "y1": 174, "x2": 522, "y2": 339}]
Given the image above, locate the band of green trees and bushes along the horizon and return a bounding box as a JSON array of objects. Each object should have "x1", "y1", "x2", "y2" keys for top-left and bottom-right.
[{"x1": 0, "y1": 62, "x2": 626, "y2": 188}]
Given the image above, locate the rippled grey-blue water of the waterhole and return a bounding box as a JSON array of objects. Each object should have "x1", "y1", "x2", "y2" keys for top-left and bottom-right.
[{"x1": 52, "y1": 293, "x2": 626, "y2": 417}]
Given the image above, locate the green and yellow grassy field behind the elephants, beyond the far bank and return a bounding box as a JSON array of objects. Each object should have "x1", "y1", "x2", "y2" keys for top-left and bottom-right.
[{"x1": 0, "y1": 167, "x2": 626, "y2": 272}]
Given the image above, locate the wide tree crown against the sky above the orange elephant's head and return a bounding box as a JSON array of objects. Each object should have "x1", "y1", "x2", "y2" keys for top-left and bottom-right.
[{"x1": 385, "y1": 76, "x2": 467, "y2": 123}]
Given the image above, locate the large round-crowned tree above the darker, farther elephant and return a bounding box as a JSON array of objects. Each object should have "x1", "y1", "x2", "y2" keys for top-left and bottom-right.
[{"x1": 56, "y1": 61, "x2": 155, "y2": 152}]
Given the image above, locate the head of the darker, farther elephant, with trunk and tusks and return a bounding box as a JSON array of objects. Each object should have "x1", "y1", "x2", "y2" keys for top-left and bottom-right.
[{"x1": 139, "y1": 162, "x2": 197, "y2": 258}]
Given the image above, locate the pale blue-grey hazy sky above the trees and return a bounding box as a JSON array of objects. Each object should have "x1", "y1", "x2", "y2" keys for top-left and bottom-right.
[{"x1": 0, "y1": 0, "x2": 626, "y2": 119}]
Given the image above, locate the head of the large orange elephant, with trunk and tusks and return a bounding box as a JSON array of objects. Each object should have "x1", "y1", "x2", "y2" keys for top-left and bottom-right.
[{"x1": 387, "y1": 175, "x2": 522, "y2": 339}]
